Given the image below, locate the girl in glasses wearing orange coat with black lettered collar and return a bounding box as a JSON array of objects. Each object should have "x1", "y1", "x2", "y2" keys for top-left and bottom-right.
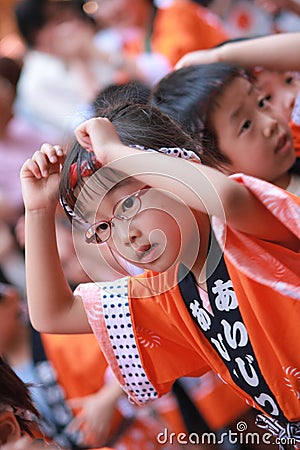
[{"x1": 21, "y1": 104, "x2": 300, "y2": 442}]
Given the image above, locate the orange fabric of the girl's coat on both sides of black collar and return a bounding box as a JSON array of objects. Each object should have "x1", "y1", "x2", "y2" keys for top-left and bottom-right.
[{"x1": 77, "y1": 176, "x2": 300, "y2": 421}]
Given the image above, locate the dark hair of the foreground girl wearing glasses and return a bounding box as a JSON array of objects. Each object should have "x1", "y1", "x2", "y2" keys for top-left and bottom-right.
[{"x1": 60, "y1": 85, "x2": 198, "y2": 221}]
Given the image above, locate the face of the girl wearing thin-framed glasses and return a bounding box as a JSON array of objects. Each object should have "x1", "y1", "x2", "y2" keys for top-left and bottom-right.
[{"x1": 84, "y1": 180, "x2": 199, "y2": 272}]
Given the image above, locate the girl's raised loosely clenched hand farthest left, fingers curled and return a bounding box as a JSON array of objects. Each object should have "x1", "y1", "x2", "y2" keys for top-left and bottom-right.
[{"x1": 20, "y1": 144, "x2": 64, "y2": 211}]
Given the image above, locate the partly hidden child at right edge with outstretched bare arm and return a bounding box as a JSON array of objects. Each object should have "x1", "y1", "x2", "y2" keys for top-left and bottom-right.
[{"x1": 176, "y1": 32, "x2": 300, "y2": 160}]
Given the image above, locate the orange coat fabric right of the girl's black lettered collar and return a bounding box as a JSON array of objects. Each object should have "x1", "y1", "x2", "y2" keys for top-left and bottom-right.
[{"x1": 213, "y1": 175, "x2": 300, "y2": 421}]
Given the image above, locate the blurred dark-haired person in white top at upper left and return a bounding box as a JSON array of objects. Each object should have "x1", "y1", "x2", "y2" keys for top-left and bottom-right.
[{"x1": 15, "y1": 0, "x2": 140, "y2": 140}]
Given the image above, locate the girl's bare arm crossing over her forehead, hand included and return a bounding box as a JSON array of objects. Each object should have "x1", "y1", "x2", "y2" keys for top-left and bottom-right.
[{"x1": 76, "y1": 118, "x2": 299, "y2": 250}]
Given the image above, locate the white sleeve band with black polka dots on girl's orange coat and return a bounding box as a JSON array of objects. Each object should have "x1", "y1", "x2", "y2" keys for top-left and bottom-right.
[{"x1": 101, "y1": 278, "x2": 158, "y2": 403}]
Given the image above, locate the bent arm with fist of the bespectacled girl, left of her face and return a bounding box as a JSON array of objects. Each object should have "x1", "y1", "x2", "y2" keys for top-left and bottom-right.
[{"x1": 20, "y1": 144, "x2": 91, "y2": 333}]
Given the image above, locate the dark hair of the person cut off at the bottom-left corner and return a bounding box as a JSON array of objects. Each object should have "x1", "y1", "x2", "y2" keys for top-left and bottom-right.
[{"x1": 0, "y1": 356, "x2": 39, "y2": 436}]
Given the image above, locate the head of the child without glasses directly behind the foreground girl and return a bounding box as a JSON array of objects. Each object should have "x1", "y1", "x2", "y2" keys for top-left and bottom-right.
[{"x1": 152, "y1": 63, "x2": 300, "y2": 195}]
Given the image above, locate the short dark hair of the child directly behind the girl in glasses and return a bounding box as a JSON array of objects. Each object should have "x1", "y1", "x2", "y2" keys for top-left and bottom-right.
[{"x1": 150, "y1": 63, "x2": 252, "y2": 169}]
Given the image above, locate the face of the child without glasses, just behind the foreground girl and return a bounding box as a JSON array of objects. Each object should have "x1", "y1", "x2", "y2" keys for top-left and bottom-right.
[{"x1": 211, "y1": 78, "x2": 295, "y2": 188}]
